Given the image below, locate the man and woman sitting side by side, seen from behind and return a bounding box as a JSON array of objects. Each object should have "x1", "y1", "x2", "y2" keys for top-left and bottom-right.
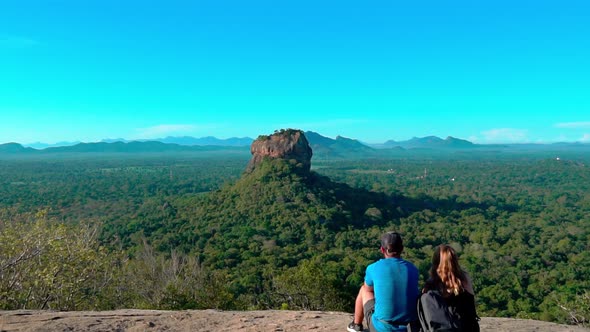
[{"x1": 347, "y1": 232, "x2": 479, "y2": 332}]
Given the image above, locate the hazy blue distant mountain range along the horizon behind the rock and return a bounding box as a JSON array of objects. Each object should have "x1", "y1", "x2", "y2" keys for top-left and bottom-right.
[{"x1": 0, "y1": 131, "x2": 590, "y2": 159}]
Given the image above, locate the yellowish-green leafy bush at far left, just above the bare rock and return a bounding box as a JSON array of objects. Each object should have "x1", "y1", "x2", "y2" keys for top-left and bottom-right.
[{"x1": 0, "y1": 210, "x2": 120, "y2": 310}]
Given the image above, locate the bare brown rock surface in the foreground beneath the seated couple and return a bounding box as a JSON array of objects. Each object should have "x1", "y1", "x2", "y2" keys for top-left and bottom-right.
[{"x1": 0, "y1": 310, "x2": 590, "y2": 332}]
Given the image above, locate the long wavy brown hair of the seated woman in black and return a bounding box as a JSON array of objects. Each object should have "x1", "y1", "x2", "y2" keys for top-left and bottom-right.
[{"x1": 430, "y1": 244, "x2": 466, "y2": 295}]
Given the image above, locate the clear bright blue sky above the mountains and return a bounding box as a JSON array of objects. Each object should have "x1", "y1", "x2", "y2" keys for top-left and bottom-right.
[{"x1": 0, "y1": 0, "x2": 590, "y2": 143}]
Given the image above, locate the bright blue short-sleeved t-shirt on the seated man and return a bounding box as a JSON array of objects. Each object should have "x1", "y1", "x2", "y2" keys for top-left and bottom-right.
[{"x1": 365, "y1": 258, "x2": 419, "y2": 331}]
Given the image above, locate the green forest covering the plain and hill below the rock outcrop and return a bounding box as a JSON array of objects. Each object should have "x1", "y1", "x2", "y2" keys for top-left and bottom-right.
[{"x1": 0, "y1": 151, "x2": 590, "y2": 324}]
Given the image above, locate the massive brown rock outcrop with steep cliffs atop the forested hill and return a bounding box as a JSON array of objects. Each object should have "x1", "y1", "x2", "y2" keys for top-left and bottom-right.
[{"x1": 246, "y1": 129, "x2": 313, "y2": 172}]
